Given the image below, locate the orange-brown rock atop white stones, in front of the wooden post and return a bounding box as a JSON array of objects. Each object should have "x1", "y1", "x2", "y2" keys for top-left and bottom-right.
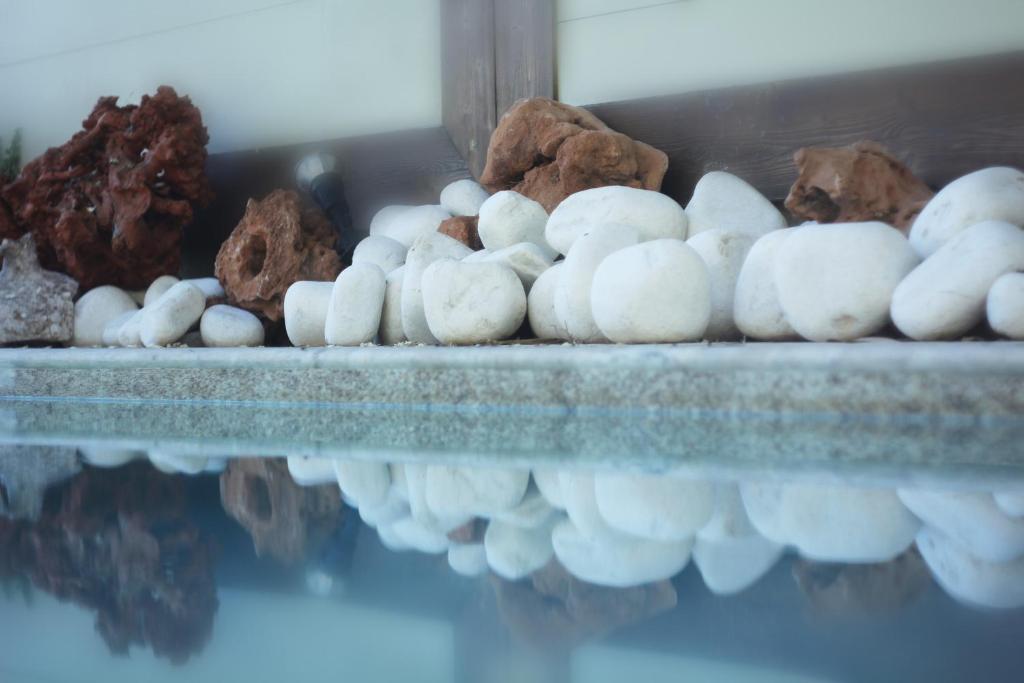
[{"x1": 480, "y1": 97, "x2": 669, "y2": 213}]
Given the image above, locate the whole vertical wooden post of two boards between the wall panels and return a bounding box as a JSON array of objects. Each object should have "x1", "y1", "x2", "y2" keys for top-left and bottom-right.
[{"x1": 441, "y1": 0, "x2": 555, "y2": 178}]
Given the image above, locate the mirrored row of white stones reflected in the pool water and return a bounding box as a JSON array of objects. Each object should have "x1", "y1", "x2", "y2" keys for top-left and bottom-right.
[{"x1": 82, "y1": 450, "x2": 1024, "y2": 608}]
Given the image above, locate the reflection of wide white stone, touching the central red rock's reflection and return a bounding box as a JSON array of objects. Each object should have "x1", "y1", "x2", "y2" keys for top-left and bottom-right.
[{"x1": 551, "y1": 520, "x2": 692, "y2": 588}]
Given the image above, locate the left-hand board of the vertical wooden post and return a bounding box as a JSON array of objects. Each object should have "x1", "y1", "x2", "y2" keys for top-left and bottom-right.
[{"x1": 441, "y1": 0, "x2": 497, "y2": 177}]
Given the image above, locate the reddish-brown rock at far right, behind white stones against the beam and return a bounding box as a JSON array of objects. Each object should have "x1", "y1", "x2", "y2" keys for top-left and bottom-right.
[{"x1": 785, "y1": 140, "x2": 934, "y2": 232}]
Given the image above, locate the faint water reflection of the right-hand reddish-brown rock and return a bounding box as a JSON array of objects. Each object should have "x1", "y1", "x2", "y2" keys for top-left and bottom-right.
[{"x1": 793, "y1": 547, "x2": 932, "y2": 615}]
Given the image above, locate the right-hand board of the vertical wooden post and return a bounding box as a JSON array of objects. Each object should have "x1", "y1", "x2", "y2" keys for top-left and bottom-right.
[{"x1": 495, "y1": 0, "x2": 555, "y2": 119}]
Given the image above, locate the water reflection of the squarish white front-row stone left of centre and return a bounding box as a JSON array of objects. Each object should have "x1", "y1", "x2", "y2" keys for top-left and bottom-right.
[{"x1": 426, "y1": 465, "x2": 529, "y2": 517}]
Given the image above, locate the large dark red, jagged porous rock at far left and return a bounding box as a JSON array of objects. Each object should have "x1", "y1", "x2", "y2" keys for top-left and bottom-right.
[{"x1": 0, "y1": 86, "x2": 211, "y2": 291}]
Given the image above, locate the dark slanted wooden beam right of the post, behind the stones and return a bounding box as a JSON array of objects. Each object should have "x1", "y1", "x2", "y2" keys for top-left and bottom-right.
[{"x1": 587, "y1": 52, "x2": 1024, "y2": 204}]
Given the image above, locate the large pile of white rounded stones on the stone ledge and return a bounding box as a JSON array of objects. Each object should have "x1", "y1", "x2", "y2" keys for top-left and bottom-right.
[{"x1": 285, "y1": 168, "x2": 1024, "y2": 346}]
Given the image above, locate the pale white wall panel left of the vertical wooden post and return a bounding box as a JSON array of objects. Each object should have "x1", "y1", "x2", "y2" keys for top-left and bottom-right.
[{"x1": 0, "y1": 0, "x2": 441, "y2": 159}]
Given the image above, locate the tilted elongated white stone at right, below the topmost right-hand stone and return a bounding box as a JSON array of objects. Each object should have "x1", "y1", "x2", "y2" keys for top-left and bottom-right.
[{"x1": 892, "y1": 221, "x2": 1024, "y2": 341}]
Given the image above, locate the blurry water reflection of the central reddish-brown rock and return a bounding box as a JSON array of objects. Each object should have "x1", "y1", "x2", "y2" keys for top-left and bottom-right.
[{"x1": 492, "y1": 560, "x2": 676, "y2": 646}]
